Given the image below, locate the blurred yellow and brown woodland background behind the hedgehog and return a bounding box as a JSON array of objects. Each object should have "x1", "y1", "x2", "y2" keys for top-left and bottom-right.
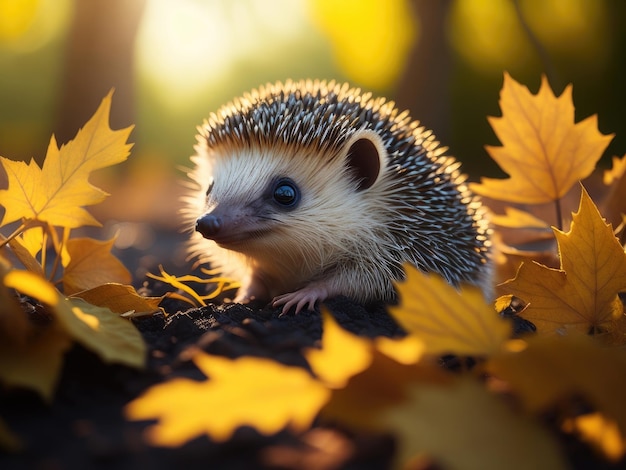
[{"x1": 0, "y1": 0, "x2": 626, "y2": 276}]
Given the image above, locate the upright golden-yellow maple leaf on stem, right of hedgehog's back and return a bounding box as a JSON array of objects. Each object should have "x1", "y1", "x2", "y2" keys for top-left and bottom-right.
[{"x1": 470, "y1": 73, "x2": 613, "y2": 204}]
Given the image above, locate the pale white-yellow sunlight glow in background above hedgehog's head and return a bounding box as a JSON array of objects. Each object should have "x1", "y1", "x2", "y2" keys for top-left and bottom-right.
[{"x1": 137, "y1": 0, "x2": 306, "y2": 109}]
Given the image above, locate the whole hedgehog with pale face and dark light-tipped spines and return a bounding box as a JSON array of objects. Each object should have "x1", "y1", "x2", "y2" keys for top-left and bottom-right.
[{"x1": 183, "y1": 80, "x2": 491, "y2": 313}]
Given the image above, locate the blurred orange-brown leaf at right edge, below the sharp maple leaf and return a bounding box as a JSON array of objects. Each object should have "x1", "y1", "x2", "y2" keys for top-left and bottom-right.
[{"x1": 486, "y1": 334, "x2": 626, "y2": 435}]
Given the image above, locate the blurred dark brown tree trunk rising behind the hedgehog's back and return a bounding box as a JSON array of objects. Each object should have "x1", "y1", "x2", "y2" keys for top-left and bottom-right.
[{"x1": 396, "y1": 0, "x2": 452, "y2": 145}]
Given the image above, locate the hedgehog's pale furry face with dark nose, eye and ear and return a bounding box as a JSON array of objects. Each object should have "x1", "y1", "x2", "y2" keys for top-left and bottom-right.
[{"x1": 197, "y1": 132, "x2": 384, "y2": 276}]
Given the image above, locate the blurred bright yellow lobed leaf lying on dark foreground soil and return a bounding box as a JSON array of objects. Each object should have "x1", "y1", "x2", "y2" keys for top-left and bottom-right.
[{"x1": 125, "y1": 353, "x2": 330, "y2": 447}]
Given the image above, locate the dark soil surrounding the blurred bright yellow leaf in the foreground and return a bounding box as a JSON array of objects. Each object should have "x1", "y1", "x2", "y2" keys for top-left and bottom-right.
[{"x1": 0, "y1": 292, "x2": 401, "y2": 470}]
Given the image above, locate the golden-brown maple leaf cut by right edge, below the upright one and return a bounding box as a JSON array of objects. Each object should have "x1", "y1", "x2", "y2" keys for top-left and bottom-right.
[{"x1": 502, "y1": 188, "x2": 626, "y2": 333}]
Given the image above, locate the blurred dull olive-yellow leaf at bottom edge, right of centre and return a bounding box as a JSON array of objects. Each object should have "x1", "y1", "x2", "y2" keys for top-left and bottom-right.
[{"x1": 379, "y1": 378, "x2": 567, "y2": 470}]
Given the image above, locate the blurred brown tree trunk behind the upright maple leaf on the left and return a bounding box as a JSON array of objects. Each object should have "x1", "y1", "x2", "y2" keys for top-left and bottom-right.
[{"x1": 55, "y1": 0, "x2": 146, "y2": 144}]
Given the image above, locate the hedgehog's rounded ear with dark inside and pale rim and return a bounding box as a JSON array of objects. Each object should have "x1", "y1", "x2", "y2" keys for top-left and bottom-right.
[{"x1": 344, "y1": 130, "x2": 387, "y2": 191}]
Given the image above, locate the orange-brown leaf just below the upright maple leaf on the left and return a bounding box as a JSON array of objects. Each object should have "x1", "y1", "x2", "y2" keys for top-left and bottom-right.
[{"x1": 63, "y1": 238, "x2": 132, "y2": 295}]
